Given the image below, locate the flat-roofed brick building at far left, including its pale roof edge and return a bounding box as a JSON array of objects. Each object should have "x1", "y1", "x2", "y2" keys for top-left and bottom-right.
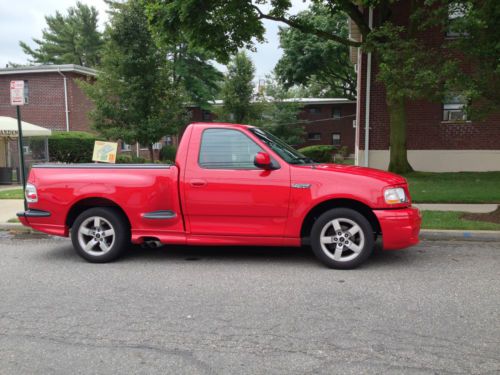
[{"x1": 0, "y1": 65, "x2": 96, "y2": 131}]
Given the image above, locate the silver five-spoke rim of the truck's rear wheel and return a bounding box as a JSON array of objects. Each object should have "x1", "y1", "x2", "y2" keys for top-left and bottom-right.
[{"x1": 78, "y1": 216, "x2": 116, "y2": 256}]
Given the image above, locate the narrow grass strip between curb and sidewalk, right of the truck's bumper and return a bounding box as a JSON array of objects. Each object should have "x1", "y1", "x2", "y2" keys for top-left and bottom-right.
[{"x1": 422, "y1": 211, "x2": 500, "y2": 230}]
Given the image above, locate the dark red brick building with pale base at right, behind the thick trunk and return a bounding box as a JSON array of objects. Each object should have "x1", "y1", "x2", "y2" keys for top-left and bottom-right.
[{"x1": 351, "y1": 1, "x2": 500, "y2": 172}]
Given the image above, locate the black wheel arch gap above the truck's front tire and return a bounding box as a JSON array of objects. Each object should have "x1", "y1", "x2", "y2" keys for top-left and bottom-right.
[{"x1": 300, "y1": 198, "x2": 382, "y2": 240}]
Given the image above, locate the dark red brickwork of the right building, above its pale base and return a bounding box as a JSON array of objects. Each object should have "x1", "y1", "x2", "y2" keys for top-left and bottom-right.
[{"x1": 358, "y1": 2, "x2": 500, "y2": 150}]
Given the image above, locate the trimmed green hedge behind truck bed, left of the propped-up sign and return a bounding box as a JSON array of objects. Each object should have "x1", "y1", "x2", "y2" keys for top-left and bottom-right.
[{"x1": 49, "y1": 132, "x2": 97, "y2": 163}]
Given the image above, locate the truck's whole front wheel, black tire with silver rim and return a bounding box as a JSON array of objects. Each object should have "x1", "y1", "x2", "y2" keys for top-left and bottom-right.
[{"x1": 311, "y1": 208, "x2": 374, "y2": 269}]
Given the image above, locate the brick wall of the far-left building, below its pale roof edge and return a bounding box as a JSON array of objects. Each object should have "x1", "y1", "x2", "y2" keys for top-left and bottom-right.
[{"x1": 0, "y1": 73, "x2": 91, "y2": 131}]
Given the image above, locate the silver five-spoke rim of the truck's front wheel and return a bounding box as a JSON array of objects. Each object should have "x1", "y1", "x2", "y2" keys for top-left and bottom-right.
[{"x1": 319, "y1": 218, "x2": 365, "y2": 262}]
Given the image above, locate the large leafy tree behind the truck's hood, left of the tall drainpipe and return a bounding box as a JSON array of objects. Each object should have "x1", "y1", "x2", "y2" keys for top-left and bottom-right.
[{"x1": 275, "y1": 4, "x2": 356, "y2": 100}]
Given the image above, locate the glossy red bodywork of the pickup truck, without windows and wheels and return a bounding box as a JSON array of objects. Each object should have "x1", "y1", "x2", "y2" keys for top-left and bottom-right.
[{"x1": 21, "y1": 123, "x2": 421, "y2": 250}]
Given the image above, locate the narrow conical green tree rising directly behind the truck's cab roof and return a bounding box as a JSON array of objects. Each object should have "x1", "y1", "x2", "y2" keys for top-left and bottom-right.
[{"x1": 221, "y1": 52, "x2": 255, "y2": 123}]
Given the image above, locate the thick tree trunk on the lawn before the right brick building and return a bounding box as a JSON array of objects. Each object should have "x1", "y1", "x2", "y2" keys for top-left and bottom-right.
[{"x1": 387, "y1": 98, "x2": 413, "y2": 173}]
